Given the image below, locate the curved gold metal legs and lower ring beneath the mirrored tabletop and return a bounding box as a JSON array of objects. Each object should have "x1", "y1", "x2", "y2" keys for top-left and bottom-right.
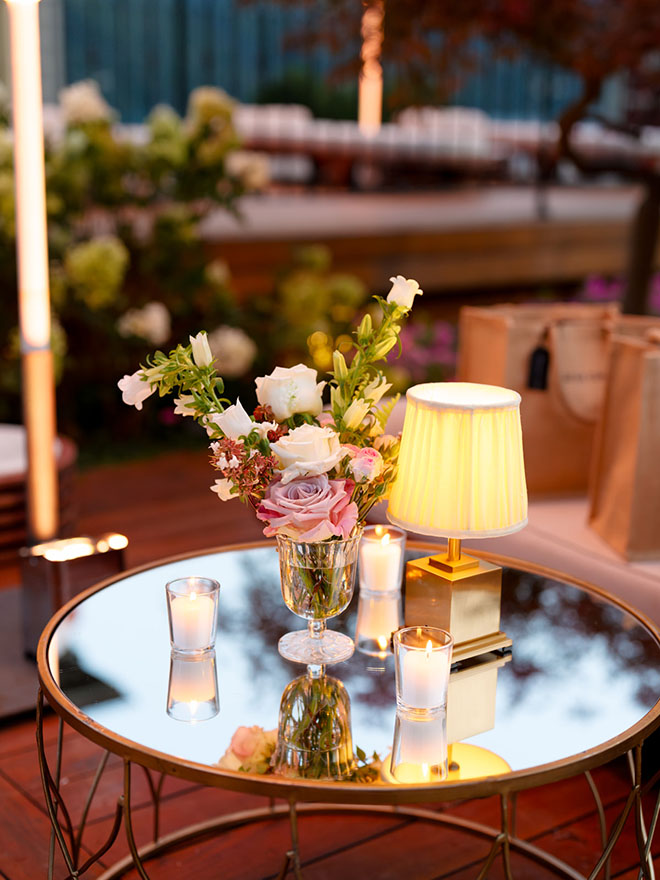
[{"x1": 37, "y1": 690, "x2": 660, "y2": 880}]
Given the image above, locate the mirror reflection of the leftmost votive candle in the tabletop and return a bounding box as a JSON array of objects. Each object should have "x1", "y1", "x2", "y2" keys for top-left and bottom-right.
[{"x1": 167, "y1": 651, "x2": 220, "y2": 724}]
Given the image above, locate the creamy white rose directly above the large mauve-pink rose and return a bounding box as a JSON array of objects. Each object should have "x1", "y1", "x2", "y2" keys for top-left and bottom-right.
[{"x1": 270, "y1": 425, "x2": 346, "y2": 483}]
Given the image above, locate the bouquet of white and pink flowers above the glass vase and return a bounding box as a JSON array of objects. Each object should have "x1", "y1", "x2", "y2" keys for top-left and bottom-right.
[{"x1": 118, "y1": 275, "x2": 422, "y2": 542}]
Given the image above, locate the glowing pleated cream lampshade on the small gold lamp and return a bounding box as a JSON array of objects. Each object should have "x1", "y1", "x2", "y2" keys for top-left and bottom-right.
[{"x1": 387, "y1": 382, "x2": 527, "y2": 538}]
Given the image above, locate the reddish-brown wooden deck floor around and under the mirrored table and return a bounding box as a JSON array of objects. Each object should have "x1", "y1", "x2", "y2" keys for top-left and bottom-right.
[{"x1": 0, "y1": 449, "x2": 660, "y2": 880}]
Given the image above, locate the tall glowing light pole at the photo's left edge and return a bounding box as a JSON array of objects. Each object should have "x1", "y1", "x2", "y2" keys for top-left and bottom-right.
[{"x1": 6, "y1": 0, "x2": 58, "y2": 541}]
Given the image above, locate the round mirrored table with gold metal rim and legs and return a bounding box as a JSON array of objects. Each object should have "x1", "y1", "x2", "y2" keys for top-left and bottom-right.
[{"x1": 37, "y1": 543, "x2": 660, "y2": 880}]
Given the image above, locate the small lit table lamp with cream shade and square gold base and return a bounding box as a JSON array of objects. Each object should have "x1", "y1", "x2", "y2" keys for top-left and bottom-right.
[{"x1": 387, "y1": 382, "x2": 527, "y2": 661}]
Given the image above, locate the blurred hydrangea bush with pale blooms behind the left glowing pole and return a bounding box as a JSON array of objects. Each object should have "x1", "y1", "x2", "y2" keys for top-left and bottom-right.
[{"x1": 0, "y1": 81, "x2": 268, "y2": 446}]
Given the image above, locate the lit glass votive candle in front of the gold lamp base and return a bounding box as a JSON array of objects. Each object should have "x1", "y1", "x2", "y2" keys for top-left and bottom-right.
[{"x1": 392, "y1": 626, "x2": 454, "y2": 715}]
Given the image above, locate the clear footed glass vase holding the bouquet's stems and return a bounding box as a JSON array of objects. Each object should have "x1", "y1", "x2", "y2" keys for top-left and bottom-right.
[{"x1": 277, "y1": 528, "x2": 362, "y2": 665}]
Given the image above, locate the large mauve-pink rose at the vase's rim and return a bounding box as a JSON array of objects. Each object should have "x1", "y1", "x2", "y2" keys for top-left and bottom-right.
[{"x1": 257, "y1": 474, "x2": 358, "y2": 541}]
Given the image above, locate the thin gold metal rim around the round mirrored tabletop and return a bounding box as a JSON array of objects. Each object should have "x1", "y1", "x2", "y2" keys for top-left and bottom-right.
[{"x1": 37, "y1": 540, "x2": 660, "y2": 804}]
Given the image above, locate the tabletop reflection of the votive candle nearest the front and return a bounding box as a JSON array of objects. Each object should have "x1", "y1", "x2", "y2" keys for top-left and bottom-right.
[{"x1": 389, "y1": 709, "x2": 448, "y2": 784}]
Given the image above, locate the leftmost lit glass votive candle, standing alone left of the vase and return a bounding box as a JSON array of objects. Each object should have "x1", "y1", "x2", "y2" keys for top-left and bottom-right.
[{"x1": 166, "y1": 577, "x2": 220, "y2": 653}]
